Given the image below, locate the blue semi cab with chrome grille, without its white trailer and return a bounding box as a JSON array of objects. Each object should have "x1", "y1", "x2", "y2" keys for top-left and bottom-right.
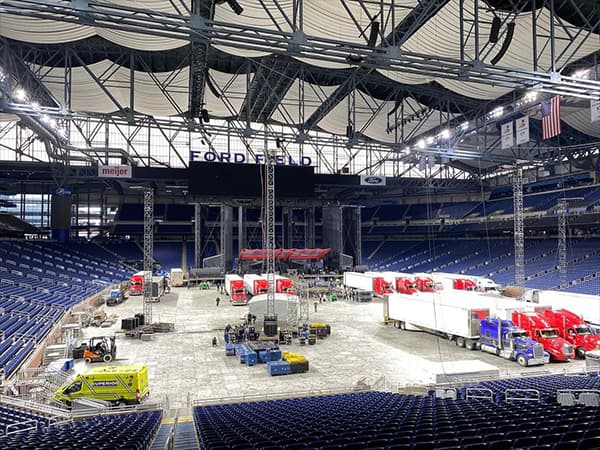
[{"x1": 479, "y1": 317, "x2": 550, "y2": 367}]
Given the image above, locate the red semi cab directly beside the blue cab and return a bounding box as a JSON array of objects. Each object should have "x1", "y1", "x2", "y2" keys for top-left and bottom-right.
[{"x1": 512, "y1": 311, "x2": 575, "y2": 361}]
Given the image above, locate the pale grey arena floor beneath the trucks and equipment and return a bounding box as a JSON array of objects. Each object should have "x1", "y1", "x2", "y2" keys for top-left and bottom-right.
[{"x1": 75, "y1": 288, "x2": 585, "y2": 409}]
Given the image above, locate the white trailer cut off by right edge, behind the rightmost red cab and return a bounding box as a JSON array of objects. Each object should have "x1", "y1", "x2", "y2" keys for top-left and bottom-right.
[{"x1": 522, "y1": 289, "x2": 600, "y2": 325}]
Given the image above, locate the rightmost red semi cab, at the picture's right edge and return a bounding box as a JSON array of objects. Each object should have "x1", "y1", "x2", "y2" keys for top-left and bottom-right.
[{"x1": 544, "y1": 309, "x2": 600, "y2": 358}]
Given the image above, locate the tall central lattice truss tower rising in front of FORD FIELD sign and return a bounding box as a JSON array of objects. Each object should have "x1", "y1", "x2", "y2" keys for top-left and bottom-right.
[{"x1": 265, "y1": 150, "x2": 276, "y2": 317}]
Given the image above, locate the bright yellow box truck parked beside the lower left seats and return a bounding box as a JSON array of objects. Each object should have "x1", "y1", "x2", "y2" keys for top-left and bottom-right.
[{"x1": 54, "y1": 366, "x2": 150, "y2": 406}]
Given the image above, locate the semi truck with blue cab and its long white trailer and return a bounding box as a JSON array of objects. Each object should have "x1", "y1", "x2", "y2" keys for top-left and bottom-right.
[{"x1": 388, "y1": 294, "x2": 550, "y2": 366}]
